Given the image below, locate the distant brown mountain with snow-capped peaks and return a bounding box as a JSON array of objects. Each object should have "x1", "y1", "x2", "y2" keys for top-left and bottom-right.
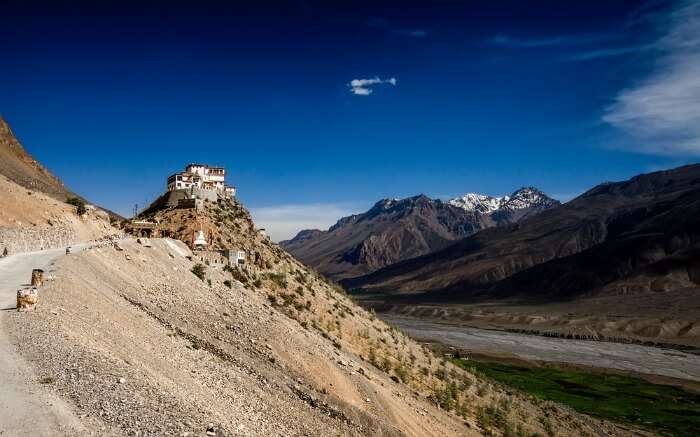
[{"x1": 280, "y1": 188, "x2": 558, "y2": 280}]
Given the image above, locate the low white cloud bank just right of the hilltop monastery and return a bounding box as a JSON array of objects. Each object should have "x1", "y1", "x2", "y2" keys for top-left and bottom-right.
[{"x1": 250, "y1": 204, "x2": 357, "y2": 241}]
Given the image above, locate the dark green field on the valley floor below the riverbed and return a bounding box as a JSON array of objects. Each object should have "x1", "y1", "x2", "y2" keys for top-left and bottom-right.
[{"x1": 455, "y1": 360, "x2": 700, "y2": 436}]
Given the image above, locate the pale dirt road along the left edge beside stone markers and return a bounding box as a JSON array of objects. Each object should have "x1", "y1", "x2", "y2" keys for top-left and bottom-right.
[{"x1": 0, "y1": 246, "x2": 84, "y2": 437}]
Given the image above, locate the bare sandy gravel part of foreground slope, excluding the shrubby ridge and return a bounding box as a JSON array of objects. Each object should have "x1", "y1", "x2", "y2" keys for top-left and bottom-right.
[{"x1": 4, "y1": 241, "x2": 475, "y2": 436}]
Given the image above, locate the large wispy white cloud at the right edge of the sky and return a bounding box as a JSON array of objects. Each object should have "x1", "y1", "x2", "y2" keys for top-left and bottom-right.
[{"x1": 603, "y1": 0, "x2": 700, "y2": 156}]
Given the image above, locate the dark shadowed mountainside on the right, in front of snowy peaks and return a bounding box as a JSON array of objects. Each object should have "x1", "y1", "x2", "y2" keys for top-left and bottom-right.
[{"x1": 346, "y1": 165, "x2": 700, "y2": 302}]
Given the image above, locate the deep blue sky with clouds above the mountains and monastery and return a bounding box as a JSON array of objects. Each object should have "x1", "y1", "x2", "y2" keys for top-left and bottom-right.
[{"x1": 0, "y1": 1, "x2": 700, "y2": 239}]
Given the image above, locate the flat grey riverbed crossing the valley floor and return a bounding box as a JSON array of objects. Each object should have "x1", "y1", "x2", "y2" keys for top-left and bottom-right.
[{"x1": 381, "y1": 314, "x2": 700, "y2": 381}]
